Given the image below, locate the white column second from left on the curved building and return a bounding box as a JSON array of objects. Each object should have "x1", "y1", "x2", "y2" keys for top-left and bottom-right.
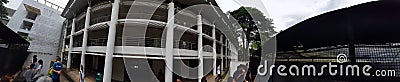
[{"x1": 79, "y1": 6, "x2": 91, "y2": 70}]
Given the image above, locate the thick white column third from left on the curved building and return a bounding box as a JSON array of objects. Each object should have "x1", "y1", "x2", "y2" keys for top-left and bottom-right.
[{"x1": 103, "y1": 0, "x2": 120, "y2": 82}]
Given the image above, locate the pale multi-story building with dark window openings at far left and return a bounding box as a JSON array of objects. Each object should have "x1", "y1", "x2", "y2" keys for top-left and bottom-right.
[{"x1": 7, "y1": 0, "x2": 65, "y2": 74}]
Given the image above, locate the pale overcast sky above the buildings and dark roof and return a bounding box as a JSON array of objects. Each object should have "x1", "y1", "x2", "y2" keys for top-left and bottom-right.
[{"x1": 5, "y1": 0, "x2": 375, "y2": 31}]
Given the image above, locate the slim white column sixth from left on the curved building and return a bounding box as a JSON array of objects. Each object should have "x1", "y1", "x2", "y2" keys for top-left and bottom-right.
[{"x1": 212, "y1": 25, "x2": 218, "y2": 76}]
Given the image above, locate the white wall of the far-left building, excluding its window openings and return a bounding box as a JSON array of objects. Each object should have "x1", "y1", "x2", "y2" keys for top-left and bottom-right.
[{"x1": 7, "y1": 0, "x2": 65, "y2": 54}]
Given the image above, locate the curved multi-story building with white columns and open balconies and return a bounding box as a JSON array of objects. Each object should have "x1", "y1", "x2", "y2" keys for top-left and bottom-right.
[{"x1": 61, "y1": 0, "x2": 237, "y2": 82}]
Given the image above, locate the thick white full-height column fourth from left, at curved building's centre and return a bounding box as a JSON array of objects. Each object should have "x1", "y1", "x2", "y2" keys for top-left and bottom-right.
[{"x1": 165, "y1": 2, "x2": 175, "y2": 82}]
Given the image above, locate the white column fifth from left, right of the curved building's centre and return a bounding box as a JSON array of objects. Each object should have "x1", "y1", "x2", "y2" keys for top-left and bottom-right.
[{"x1": 197, "y1": 15, "x2": 203, "y2": 82}]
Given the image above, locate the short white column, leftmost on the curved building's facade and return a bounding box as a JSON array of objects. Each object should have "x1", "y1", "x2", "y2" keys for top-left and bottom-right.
[{"x1": 67, "y1": 18, "x2": 75, "y2": 68}]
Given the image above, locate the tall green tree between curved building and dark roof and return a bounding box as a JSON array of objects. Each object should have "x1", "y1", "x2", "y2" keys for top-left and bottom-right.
[{"x1": 229, "y1": 7, "x2": 277, "y2": 56}]
